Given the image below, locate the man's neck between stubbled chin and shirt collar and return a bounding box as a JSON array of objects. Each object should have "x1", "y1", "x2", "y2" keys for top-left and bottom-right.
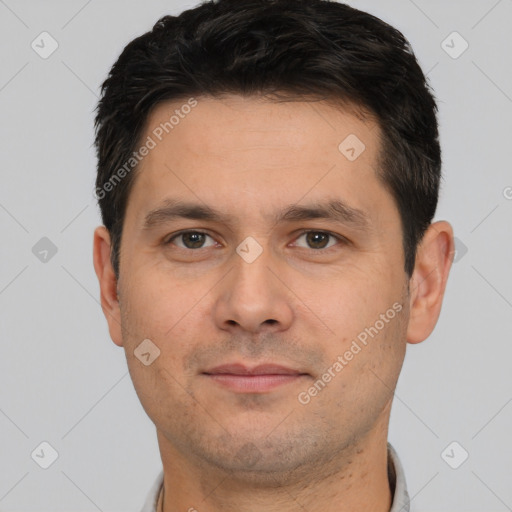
[{"x1": 157, "y1": 429, "x2": 392, "y2": 512}]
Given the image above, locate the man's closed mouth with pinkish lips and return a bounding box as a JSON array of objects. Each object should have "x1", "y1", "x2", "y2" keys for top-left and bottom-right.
[{"x1": 202, "y1": 364, "x2": 309, "y2": 393}]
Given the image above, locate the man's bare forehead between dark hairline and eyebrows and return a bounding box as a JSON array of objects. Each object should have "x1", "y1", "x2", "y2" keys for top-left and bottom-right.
[{"x1": 129, "y1": 96, "x2": 389, "y2": 230}]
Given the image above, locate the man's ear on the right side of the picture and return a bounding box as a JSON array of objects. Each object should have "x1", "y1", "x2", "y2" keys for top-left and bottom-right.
[{"x1": 407, "y1": 221, "x2": 455, "y2": 343}]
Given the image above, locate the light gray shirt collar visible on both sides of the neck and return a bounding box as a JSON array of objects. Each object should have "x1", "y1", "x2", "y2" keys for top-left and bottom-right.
[{"x1": 141, "y1": 443, "x2": 409, "y2": 512}]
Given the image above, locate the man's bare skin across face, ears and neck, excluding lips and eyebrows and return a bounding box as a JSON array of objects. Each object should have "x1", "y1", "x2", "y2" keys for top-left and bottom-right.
[{"x1": 94, "y1": 95, "x2": 454, "y2": 512}]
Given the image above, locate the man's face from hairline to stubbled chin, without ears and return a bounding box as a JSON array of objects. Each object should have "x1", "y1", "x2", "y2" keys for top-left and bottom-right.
[{"x1": 113, "y1": 96, "x2": 409, "y2": 480}]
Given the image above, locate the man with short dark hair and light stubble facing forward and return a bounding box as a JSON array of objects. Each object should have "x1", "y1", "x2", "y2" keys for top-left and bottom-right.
[{"x1": 94, "y1": 0, "x2": 454, "y2": 512}]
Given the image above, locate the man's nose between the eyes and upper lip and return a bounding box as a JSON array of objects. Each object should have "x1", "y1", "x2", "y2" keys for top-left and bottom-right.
[{"x1": 213, "y1": 245, "x2": 293, "y2": 333}]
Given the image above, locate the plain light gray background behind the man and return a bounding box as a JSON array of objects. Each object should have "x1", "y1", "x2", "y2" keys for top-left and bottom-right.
[{"x1": 0, "y1": 0, "x2": 512, "y2": 512}]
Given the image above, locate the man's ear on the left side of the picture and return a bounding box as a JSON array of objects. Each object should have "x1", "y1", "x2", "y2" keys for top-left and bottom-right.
[{"x1": 93, "y1": 226, "x2": 123, "y2": 347}]
